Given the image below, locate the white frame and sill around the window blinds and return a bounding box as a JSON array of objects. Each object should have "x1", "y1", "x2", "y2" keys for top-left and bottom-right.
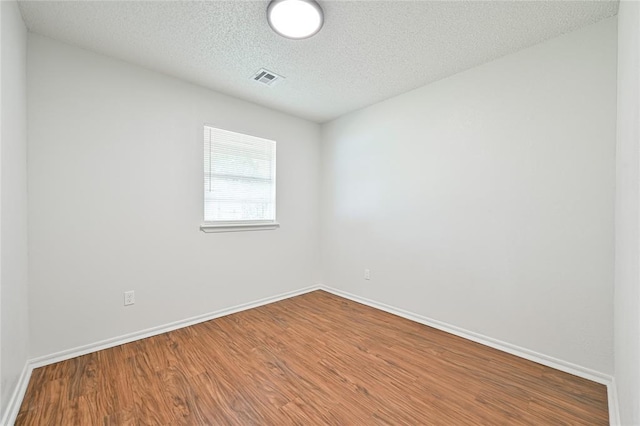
[{"x1": 200, "y1": 123, "x2": 280, "y2": 233}]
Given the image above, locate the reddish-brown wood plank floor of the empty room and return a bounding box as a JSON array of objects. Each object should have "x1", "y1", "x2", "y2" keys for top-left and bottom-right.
[{"x1": 16, "y1": 291, "x2": 608, "y2": 425}]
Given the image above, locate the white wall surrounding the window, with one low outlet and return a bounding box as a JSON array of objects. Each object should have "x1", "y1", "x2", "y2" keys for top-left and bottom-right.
[{"x1": 28, "y1": 34, "x2": 320, "y2": 356}]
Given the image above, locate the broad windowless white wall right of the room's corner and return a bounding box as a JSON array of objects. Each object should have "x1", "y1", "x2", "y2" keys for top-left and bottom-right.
[{"x1": 321, "y1": 18, "x2": 616, "y2": 374}]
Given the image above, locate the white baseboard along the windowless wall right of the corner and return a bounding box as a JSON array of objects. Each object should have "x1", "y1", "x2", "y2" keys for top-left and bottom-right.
[{"x1": 321, "y1": 285, "x2": 612, "y2": 385}]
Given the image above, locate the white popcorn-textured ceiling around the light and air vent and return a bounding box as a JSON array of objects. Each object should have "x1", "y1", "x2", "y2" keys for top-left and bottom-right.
[{"x1": 20, "y1": 0, "x2": 618, "y2": 122}]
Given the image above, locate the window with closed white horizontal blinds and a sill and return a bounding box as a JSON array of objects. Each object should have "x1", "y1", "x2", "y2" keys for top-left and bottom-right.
[{"x1": 200, "y1": 126, "x2": 278, "y2": 232}]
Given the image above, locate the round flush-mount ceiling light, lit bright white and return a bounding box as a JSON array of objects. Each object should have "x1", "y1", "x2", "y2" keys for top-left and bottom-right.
[{"x1": 267, "y1": 0, "x2": 324, "y2": 39}]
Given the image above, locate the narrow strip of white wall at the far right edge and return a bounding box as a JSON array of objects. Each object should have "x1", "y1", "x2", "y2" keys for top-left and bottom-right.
[{"x1": 614, "y1": 1, "x2": 640, "y2": 425}]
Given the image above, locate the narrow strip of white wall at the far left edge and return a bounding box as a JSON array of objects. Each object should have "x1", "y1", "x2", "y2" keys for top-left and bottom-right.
[{"x1": 0, "y1": 1, "x2": 29, "y2": 418}]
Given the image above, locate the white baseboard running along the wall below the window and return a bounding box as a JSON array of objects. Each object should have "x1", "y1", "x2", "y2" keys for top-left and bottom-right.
[{"x1": 29, "y1": 285, "x2": 320, "y2": 368}]
